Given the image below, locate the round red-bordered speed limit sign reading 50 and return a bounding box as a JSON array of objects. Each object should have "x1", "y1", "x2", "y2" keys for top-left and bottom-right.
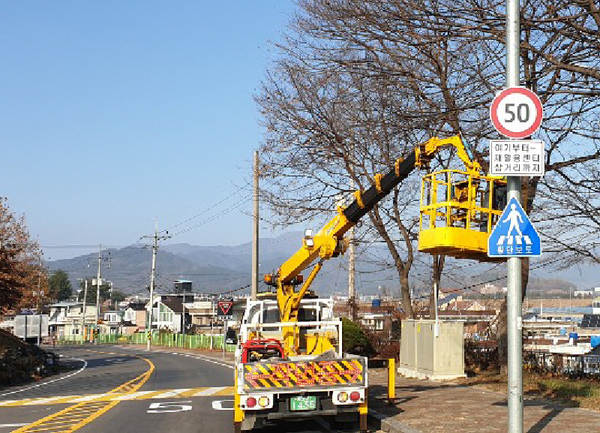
[{"x1": 490, "y1": 87, "x2": 544, "y2": 138}]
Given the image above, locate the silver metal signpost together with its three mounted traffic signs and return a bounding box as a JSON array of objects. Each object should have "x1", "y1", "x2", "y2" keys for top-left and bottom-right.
[{"x1": 488, "y1": 0, "x2": 544, "y2": 433}]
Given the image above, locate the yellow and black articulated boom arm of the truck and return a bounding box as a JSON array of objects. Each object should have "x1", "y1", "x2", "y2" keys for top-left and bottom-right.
[{"x1": 265, "y1": 136, "x2": 474, "y2": 322}]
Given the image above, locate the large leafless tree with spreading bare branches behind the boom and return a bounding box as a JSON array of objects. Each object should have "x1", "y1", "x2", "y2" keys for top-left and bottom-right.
[{"x1": 257, "y1": 0, "x2": 600, "y2": 324}]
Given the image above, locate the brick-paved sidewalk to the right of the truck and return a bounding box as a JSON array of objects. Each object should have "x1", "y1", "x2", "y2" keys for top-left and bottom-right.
[{"x1": 369, "y1": 369, "x2": 600, "y2": 433}]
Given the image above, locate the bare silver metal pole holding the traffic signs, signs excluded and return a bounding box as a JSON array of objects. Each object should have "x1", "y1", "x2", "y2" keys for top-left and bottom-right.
[{"x1": 506, "y1": 0, "x2": 523, "y2": 433}]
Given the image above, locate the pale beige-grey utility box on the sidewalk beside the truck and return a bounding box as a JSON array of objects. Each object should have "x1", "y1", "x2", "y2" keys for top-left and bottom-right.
[{"x1": 398, "y1": 320, "x2": 466, "y2": 380}]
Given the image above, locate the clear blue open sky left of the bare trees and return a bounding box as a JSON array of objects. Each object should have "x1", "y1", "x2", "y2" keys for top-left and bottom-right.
[{"x1": 0, "y1": 0, "x2": 296, "y2": 260}]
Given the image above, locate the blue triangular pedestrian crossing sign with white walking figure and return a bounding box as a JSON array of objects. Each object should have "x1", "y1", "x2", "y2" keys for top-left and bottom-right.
[{"x1": 488, "y1": 198, "x2": 542, "y2": 257}]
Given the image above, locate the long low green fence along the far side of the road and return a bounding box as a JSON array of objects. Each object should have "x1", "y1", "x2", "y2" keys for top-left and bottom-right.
[{"x1": 58, "y1": 332, "x2": 236, "y2": 352}]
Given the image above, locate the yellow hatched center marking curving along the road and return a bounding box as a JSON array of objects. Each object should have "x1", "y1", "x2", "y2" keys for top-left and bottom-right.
[{"x1": 13, "y1": 349, "x2": 155, "y2": 433}]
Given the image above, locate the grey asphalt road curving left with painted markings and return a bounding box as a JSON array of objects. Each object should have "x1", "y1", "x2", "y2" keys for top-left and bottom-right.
[{"x1": 0, "y1": 346, "x2": 352, "y2": 433}]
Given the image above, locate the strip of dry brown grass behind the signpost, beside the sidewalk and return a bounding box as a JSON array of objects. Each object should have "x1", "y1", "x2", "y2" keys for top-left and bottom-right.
[{"x1": 459, "y1": 373, "x2": 600, "y2": 412}]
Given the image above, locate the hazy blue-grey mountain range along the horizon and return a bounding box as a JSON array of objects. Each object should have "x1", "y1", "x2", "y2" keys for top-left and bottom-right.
[{"x1": 47, "y1": 232, "x2": 600, "y2": 296}]
